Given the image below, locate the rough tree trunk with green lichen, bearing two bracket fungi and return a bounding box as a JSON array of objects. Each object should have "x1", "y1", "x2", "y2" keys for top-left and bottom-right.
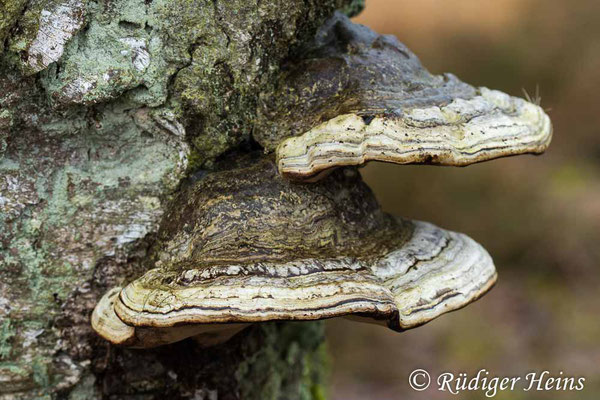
[{"x1": 0, "y1": 0, "x2": 360, "y2": 399}]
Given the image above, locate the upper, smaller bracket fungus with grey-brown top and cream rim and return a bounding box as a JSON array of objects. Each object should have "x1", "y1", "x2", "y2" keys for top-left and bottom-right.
[{"x1": 255, "y1": 14, "x2": 552, "y2": 180}]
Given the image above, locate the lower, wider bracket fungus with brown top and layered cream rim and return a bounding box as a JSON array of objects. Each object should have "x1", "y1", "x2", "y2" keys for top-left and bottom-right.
[{"x1": 92, "y1": 158, "x2": 496, "y2": 347}]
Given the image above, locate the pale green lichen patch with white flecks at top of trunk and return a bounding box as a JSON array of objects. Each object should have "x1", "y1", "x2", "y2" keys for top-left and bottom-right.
[{"x1": 42, "y1": 0, "x2": 177, "y2": 106}]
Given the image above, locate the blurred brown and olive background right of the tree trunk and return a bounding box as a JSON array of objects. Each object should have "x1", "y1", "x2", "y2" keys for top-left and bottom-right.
[{"x1": 327, "y1": 0, "x2": 600, "y2": 400}]
